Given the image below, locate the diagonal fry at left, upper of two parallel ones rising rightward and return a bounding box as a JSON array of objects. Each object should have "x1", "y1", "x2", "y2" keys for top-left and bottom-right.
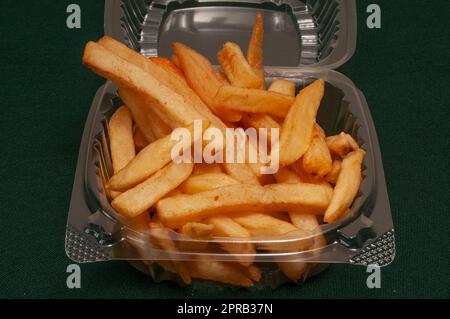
[{"x1": 107, "y1": 123, "x2": 208, "y2": 191}]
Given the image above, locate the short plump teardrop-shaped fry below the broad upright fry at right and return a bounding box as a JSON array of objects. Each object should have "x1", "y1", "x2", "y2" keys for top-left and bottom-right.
[{"x1": 303, "y1": 131, "x2": 333, "y2": 177}]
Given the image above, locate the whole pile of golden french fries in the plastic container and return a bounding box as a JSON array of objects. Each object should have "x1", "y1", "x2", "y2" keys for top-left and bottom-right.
[{"x1": 83, "y1": 14, "x2": 365, "y2": 287}]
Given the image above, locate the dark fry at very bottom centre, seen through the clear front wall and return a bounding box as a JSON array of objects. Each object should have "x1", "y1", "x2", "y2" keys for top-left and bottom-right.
[{"x1": 188, "y1": 256, "x2": 253, "y2": 287}]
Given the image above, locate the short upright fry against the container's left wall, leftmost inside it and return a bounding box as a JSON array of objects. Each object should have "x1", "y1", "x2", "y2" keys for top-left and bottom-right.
[{"x1": 109, "y1": 106, "x2": 136, "y2": 173}]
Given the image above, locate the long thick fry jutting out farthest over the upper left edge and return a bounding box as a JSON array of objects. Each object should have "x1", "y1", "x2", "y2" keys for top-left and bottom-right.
[{"x1": 83, "y1": 42, "x2": 204, "y2": 126}]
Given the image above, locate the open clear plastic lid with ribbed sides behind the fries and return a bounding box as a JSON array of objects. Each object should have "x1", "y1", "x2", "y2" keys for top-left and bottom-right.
[{"x1": 105, "y1": 0, "x2": 357, "y2": 69}]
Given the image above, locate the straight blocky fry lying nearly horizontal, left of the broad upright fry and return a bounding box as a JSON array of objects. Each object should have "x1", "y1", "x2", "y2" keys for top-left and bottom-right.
[{"x1": 212, "y1": 85, "x2": 295, "y2": 117}]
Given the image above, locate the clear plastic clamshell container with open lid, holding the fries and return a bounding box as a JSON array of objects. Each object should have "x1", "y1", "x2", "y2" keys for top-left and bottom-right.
[{"x1": 66, "y1": 0, "x2": 395, "y2": 287}]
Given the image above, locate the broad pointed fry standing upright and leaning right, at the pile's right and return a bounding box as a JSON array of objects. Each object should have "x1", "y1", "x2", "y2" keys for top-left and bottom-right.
[{"x1": 280, "y1": 79, "x2": 325, "y2": 166}]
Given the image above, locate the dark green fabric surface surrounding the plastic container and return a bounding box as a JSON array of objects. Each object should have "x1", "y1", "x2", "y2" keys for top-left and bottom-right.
[{"x1": 0, "y1": 0, "x2": 450, "y2": 298}]
